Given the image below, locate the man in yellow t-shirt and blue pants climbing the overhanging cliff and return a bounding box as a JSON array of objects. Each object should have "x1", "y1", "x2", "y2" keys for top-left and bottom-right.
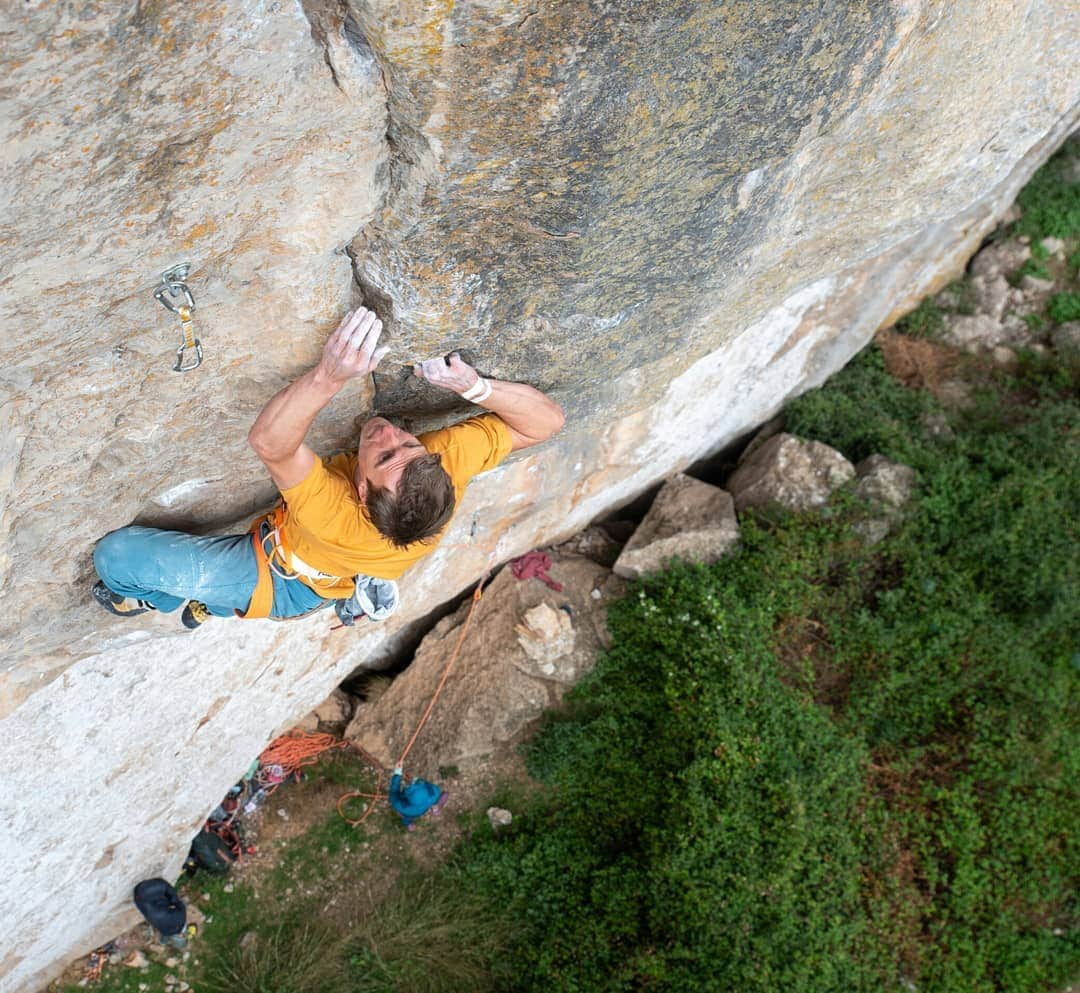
[{"x1": 93, "y1": 307, "x2": 563, "y2": 628}]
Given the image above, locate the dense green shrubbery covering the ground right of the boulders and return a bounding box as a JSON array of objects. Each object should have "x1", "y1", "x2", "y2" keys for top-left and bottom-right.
[{"x1": 451, "y1": 339, "x2": 1080, "y2": 993}]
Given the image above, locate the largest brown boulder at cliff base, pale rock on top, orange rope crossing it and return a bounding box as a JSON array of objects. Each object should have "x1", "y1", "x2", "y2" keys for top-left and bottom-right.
[{"x1": 346, "y1": 554, "x2": 624, "y2": 776}]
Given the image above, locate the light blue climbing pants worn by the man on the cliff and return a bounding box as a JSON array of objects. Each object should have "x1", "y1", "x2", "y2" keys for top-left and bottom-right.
[{"x1": 94, "y1": 527, "x2": 334, "y2": 617}]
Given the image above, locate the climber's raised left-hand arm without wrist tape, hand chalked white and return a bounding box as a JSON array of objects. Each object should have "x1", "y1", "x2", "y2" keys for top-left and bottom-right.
[{"x1": 247, "y1": 307, "x2": 389, "y2": 489}]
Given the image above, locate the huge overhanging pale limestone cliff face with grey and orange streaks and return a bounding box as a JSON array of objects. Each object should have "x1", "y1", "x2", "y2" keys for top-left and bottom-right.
[{"x1": 0, "y1": 0, "x2": 1080, "y2": 993}]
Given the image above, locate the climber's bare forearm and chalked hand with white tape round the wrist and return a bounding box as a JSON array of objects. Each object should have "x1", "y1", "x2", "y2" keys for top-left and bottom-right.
[{"x1": 413, "y1": 352, "x2": 566, "y2": 452}]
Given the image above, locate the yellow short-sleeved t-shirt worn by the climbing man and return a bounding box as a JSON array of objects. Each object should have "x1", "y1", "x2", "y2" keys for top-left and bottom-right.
[{"x1": 281, "y1": 414, "x2": 512, "y2": 599}]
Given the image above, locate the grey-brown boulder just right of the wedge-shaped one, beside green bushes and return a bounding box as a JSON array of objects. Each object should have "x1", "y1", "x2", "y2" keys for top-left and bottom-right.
[{"x1": 728, "y1": 433, "x2": 855, "y2": 512}]
